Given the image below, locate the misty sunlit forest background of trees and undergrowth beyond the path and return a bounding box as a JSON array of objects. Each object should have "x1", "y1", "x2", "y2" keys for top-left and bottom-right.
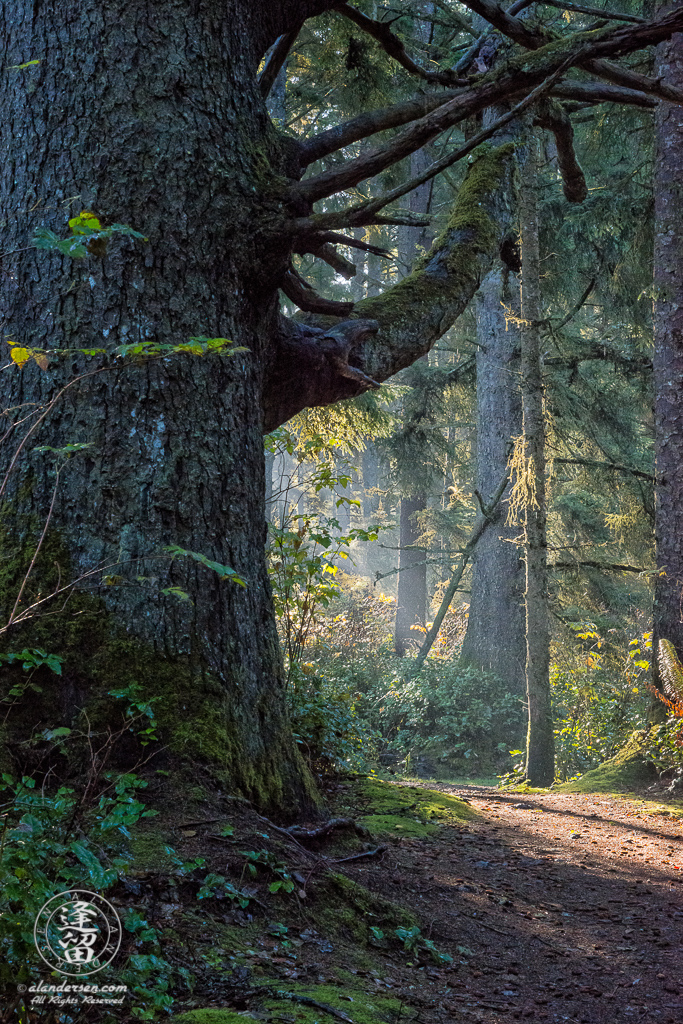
[{"x1": 266, "y1": 5, "x2": 679, "y2": 780}]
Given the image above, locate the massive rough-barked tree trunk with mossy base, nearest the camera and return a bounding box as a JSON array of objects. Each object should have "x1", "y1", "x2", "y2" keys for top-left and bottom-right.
[{"x1": 0, "y1": 0, "x2": 321, "y2": 809}]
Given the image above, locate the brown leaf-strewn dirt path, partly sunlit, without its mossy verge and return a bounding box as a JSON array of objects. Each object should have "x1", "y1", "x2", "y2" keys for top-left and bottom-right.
[{"x1": 335, "y1": 782, "x2": 683, "y2": 1024}]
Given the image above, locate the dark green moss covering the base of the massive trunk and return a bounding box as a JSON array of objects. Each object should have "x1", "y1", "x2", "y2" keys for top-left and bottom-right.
[{"x1": 0, "y1": 520, "x2": 319, "y2": 812}]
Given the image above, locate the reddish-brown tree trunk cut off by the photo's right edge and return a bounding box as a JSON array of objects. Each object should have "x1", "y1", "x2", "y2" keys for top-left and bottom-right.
[{"x1": 653, "y1": 4, "x2": 683, "y2": 700}]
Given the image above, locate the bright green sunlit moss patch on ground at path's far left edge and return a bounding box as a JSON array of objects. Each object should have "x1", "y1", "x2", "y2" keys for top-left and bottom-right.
[{"x1": 354, "y1": 779, "x2": 477, "y2": 838}]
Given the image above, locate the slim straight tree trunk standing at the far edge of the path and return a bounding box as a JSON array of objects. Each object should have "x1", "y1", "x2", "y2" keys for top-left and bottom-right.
[{"x1": 517, "y1": 134, "x2": 555, "y2": 785}]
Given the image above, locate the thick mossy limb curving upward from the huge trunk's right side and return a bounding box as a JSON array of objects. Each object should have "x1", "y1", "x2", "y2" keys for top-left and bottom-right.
[{"x1": 264, "y1": 144, "x2": 514, "y2": 430}]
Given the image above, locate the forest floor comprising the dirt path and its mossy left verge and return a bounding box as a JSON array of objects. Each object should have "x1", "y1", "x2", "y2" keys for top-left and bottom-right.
[{"x1": 166, "y1": 780, "x2": 683, "y2": 1024}]
